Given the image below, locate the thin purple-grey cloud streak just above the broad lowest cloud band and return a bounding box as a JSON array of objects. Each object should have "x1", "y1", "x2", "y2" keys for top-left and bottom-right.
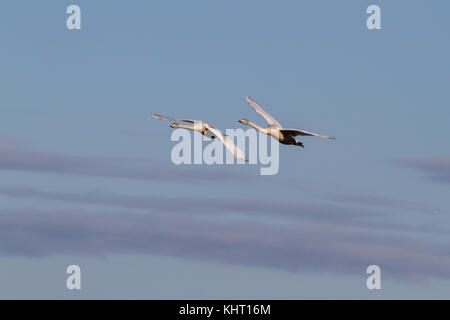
[{"x1": 0, "y1": 186, "x2": 387, "y2": 221}]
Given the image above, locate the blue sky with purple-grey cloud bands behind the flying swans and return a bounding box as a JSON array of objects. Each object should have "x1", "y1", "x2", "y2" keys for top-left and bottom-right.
[{"x1": 0, "y1": 0, "x2": 450, "y2": 299}]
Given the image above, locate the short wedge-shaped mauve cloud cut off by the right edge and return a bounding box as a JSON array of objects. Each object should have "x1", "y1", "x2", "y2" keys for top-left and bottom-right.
[{"x1": 395, "y1": 156, "x2": 450, "y2": 183}]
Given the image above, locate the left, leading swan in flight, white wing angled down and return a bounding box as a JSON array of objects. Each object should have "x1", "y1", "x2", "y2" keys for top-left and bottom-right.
[{"x1": 151, "y1": 112, "x2": 248, "y2": 162}]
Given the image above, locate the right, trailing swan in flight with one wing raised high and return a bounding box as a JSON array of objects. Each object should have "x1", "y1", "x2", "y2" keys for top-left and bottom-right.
[{"x1": 239, "y1": 95, "x2": 336, "y2": 148}]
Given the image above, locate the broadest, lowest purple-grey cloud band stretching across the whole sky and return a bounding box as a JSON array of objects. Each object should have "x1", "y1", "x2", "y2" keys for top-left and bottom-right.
[{"x1": 0, "y1": 209, "x2": 450, "y2": 279}]
